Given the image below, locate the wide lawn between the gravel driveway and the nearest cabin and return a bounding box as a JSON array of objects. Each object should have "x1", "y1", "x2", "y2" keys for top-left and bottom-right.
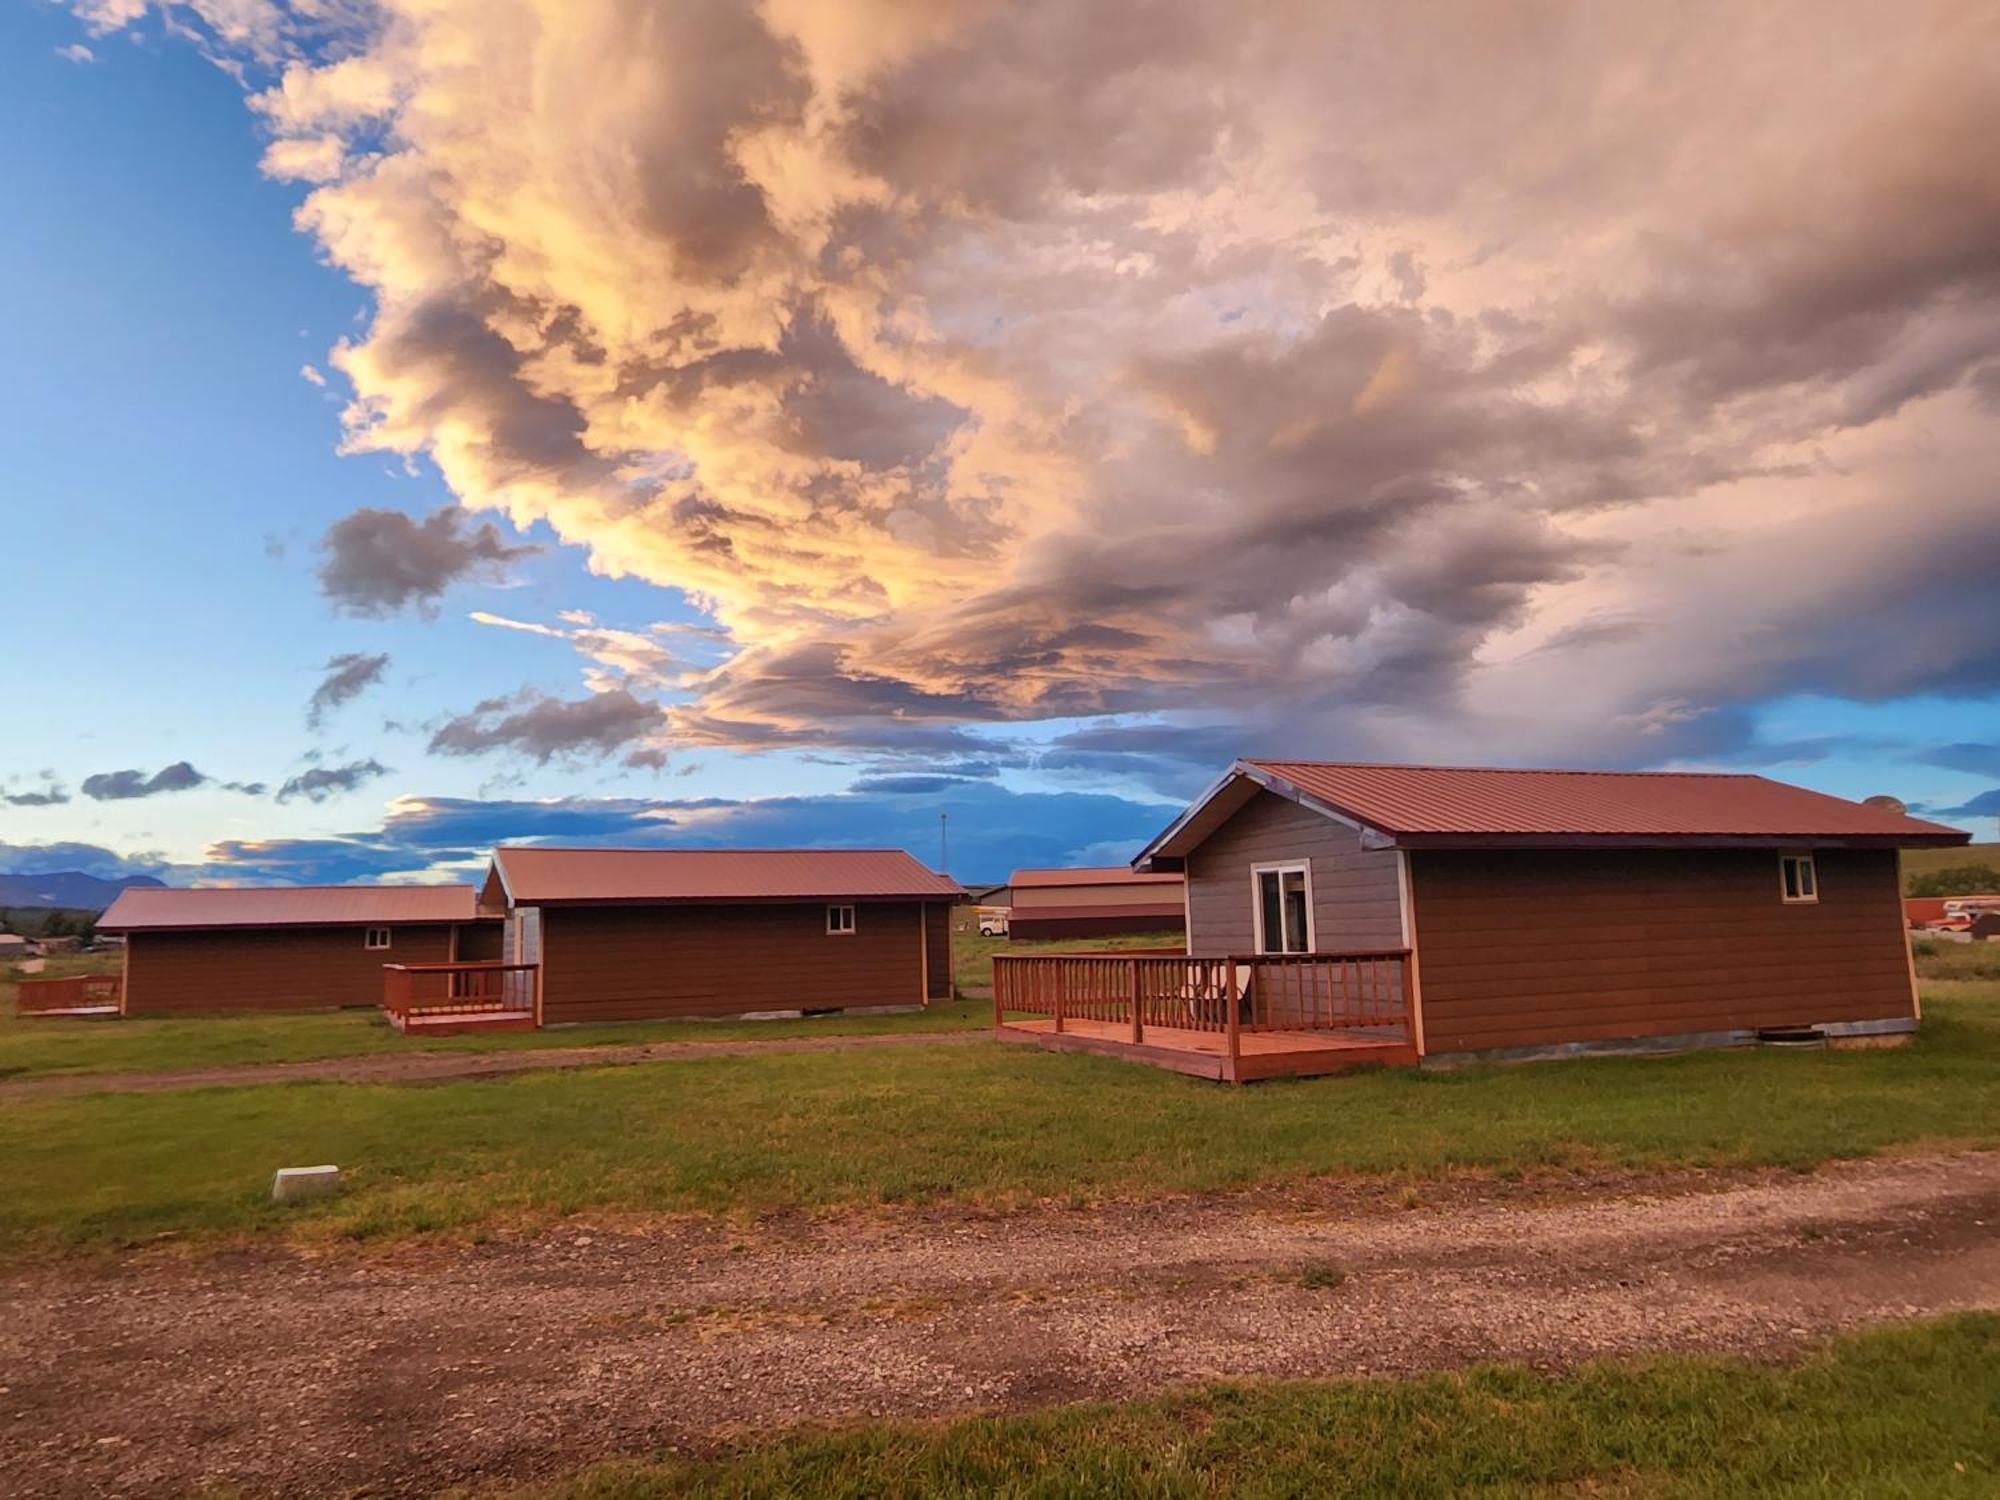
[{"x1": 0, "y1": 984, "x2": 2000, "y2": 1256}]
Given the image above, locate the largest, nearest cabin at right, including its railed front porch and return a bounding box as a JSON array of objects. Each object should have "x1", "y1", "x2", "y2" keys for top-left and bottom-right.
[{"x1": 994, "y1": 760, "x2": 1970, "y2": 1082}]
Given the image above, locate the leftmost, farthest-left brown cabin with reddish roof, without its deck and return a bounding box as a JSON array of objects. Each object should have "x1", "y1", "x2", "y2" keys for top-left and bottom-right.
[{"x1": 98, "y1": 886, "x2": 502, "y2": 1016}]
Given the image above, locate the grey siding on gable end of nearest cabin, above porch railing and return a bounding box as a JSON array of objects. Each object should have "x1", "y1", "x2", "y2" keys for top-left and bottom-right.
[{"x1": 1184, "y1": 792, "x2": 1402, "y2": 956}]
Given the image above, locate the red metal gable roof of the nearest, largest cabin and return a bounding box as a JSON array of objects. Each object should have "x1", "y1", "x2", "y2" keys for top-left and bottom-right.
[{"x1": 1134, "y1": 760, "x2": 1972, "y2": 868}]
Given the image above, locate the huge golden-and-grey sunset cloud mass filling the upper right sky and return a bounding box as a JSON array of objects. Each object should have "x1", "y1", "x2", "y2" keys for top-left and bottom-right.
[{"x1": 82, "y1": 0, "x2": 2000, "y2": 780}]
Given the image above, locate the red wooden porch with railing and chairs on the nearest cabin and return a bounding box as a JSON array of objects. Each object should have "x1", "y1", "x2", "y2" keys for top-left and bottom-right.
[{"x1": 992, "y1": 948, "x2": 1418, "y2": 1084}]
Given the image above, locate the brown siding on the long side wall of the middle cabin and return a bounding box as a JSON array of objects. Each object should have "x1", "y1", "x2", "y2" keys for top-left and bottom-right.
[{"x1": 542, "y1": 902, "x2": 926, "y2": 1024}]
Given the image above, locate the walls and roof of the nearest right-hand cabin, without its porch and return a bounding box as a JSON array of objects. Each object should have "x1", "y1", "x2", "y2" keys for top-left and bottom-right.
[{"x1": 1134, "y1": 760, "x2": 1970, "y2": 1060}]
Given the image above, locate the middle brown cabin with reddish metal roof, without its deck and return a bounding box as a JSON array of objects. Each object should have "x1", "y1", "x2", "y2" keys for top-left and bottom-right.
[{"x1": 480, "y1": 846, "x2": 964, "y2": 1024}]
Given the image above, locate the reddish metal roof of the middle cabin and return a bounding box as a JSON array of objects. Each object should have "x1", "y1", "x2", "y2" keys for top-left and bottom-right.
[{"x1": 480, "y1": 844, "x2": 964, "y2": 906}]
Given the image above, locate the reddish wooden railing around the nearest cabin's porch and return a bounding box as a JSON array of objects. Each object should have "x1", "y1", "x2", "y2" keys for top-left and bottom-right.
[{"x1": 994, "y1": 948, "x2": 1410, "y2": 1052}]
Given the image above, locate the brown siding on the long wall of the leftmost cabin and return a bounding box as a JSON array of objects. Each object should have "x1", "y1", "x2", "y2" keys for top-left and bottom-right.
[{"x1": 126, "y1": 924, "x2": 452, "y2": 1016}]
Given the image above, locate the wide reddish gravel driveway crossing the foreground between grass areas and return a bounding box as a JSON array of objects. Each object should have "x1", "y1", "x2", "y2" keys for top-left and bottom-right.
[{"x1": 11, "y1": 1154, "x2": 2000, "y2": 1496}]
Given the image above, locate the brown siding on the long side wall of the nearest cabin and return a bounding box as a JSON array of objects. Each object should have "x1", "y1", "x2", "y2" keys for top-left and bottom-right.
[{"x1": 1410, "y1": 850, "x2": 1914, "y2": 1054}]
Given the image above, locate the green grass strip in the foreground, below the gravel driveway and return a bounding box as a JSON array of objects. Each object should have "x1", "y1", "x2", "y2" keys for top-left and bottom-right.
[{"x1": 472, "y1": 1314, "x2": 2000, "y2": 1500}]
